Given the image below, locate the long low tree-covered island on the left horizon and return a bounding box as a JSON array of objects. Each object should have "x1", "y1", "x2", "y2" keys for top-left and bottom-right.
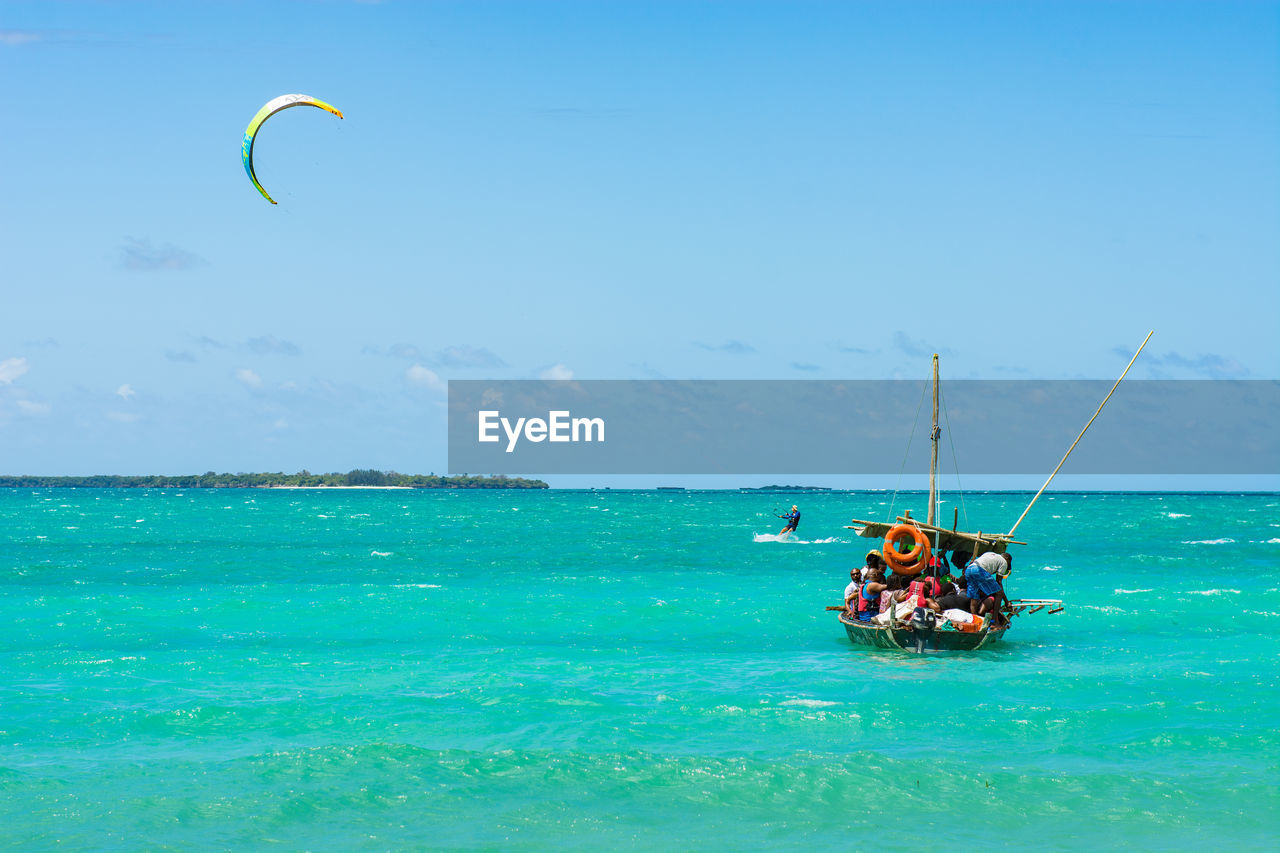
[{"x1": 0, "y1": 469, "x2": 548, "y2": 489}]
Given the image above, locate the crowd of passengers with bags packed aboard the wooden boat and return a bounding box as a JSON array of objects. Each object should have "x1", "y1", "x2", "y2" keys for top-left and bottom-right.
[{"x1": 845, "y1": 540, "x2": 1012, "y2": 631}]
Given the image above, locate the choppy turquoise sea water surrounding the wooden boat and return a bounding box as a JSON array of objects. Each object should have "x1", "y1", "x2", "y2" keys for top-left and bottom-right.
[{"x1": 0, "y1": 489, "x2": 1280, "y2": 850}]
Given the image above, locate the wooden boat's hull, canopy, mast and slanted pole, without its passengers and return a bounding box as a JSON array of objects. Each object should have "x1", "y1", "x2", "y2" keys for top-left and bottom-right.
[{"x1": 827, "y1": 333, "x2": 1153, "y2": 653}]
